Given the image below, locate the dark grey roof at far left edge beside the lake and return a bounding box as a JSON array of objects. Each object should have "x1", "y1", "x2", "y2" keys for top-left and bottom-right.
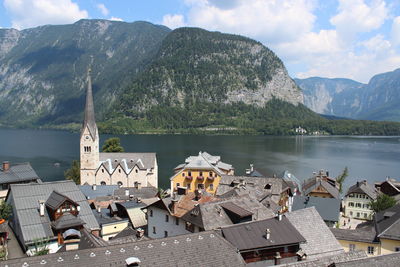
[{"x1": 0, "y1": 163, "x2": 39, "y2": 184}]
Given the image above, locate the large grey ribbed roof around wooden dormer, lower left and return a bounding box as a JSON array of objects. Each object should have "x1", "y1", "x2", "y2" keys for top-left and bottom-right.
[{"x1": 6, "y1": 181, "x2": 100, "y2": 244}]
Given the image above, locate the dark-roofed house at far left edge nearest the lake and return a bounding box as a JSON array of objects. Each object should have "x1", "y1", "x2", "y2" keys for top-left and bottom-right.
[{"x1": 0, "y1": 161, "x2": 41, "y2": 200}]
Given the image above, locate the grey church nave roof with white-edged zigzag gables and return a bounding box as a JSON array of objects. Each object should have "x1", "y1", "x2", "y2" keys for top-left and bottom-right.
[{"x1": 100, "y1": 152, "x2": 157, "y2": 173}]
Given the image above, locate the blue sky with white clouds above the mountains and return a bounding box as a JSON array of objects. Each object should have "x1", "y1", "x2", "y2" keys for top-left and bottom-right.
[{"x1": 0, "y1": 0, "x2": 400, "y2": 83}]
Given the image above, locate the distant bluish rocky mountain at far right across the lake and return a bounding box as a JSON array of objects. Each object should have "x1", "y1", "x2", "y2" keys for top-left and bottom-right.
[{"x1": 295, "y1": 69, "x2": 400, "y2": 121}]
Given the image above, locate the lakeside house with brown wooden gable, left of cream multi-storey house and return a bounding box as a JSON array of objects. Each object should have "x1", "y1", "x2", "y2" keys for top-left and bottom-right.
[{"x1": 302, "y1": 170, "x2": 340, "y2": 199}]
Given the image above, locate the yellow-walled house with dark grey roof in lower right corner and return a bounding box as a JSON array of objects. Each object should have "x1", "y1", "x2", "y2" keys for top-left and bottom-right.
[{"x1": 332, "y1": 204, "x2": 400, "y2": 256}]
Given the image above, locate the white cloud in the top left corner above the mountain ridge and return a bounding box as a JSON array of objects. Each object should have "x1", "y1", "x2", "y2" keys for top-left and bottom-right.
[{"x1": 4, "y1": 0, "x2": 88, "y2": 29}]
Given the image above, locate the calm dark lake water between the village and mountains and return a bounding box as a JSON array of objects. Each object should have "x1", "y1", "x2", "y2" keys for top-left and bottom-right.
[{"x1": 0, "y1": 129, "x2": 400, "y2": 192}]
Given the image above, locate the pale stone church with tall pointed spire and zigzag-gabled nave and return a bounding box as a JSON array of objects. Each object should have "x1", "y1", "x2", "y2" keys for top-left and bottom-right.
[{"x1": 80, "y1": 69, "x2": 158, "y2": 187}]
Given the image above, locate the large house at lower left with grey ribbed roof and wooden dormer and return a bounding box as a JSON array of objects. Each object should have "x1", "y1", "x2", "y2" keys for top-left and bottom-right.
[{"x1": 6, "y1": 181, "x2": 100, "y2": 255}]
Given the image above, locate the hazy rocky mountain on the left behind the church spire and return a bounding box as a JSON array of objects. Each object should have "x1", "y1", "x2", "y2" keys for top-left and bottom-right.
[{"x1": 0, "y1": 20, "x2": 170, "y2": 126}]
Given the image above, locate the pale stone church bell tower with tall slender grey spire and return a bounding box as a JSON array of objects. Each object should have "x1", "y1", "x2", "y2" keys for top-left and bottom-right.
[{"x1": 80, "y1": 68, "x2": 100, "y2": 185}]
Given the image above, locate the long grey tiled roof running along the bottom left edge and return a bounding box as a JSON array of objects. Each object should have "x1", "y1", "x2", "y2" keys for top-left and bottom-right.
[{"x1": 3, "y1": 231, "x2": 245, "y2": 267}]
